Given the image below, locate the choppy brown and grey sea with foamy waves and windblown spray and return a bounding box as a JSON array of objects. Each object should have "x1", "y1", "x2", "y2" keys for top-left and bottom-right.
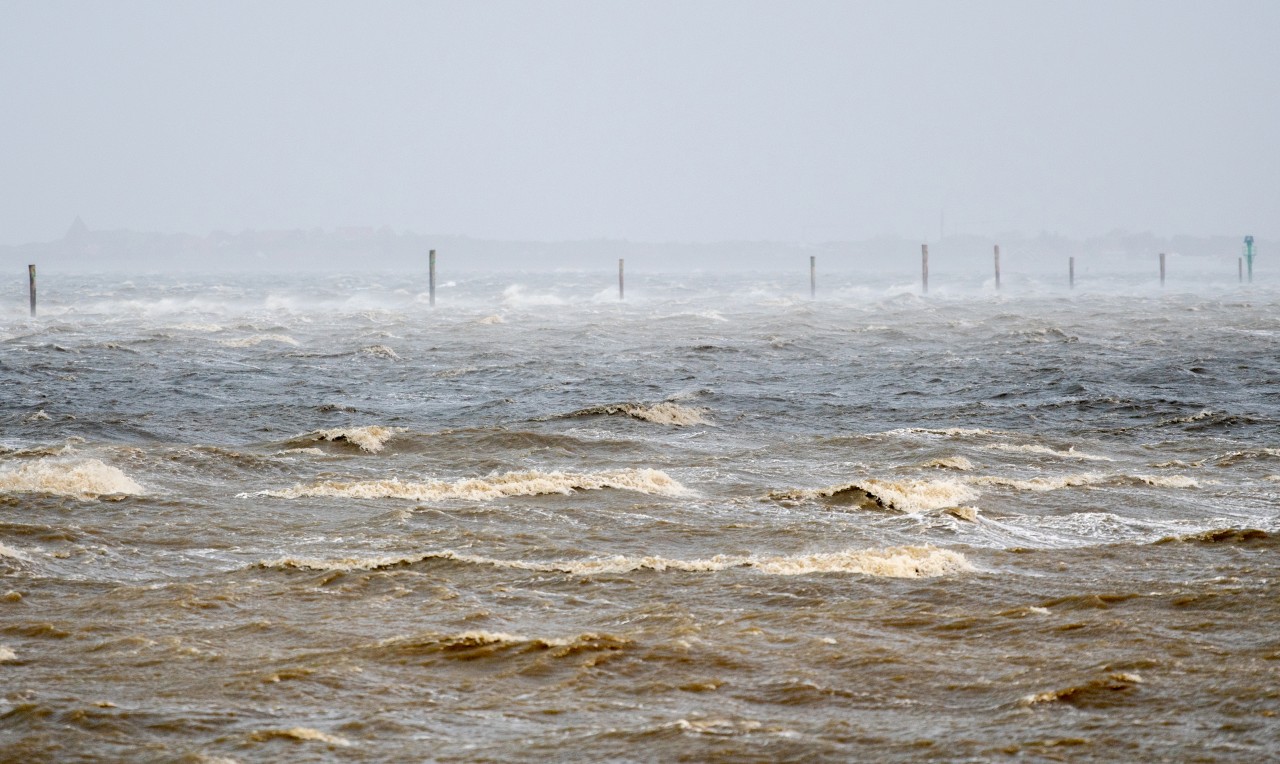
[{"x1": 0, "y1": 274, "x2": 1280, "y2": 761}]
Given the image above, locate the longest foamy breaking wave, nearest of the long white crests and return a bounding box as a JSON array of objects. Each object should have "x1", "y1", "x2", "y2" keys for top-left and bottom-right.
[{"x1": 259, "y1": 546, "x2": 974, "y2": 578}]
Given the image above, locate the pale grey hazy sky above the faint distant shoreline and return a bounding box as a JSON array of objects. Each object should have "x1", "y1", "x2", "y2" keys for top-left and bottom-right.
[{"x1": 0, "y1": 0, "x2": 1280, "y2": 243}]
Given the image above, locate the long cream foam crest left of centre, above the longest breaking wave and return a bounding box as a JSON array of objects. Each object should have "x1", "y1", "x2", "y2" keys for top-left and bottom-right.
[{"x1": 260, "y1": 468, "x2": 690, "y2": 502}]
